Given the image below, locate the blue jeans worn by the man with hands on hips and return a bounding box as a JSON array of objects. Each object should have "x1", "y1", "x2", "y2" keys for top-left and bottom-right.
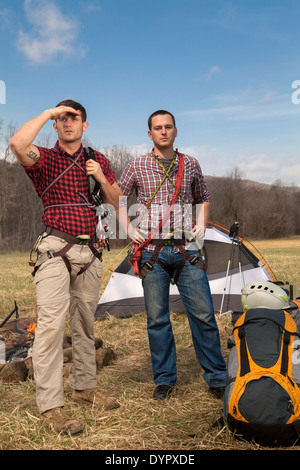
[{"x1": 141, "y1": 246, "x2": 226, "y2": 388}]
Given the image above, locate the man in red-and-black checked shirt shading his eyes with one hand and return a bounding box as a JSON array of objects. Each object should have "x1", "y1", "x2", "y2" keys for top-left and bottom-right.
[{"x1": 10, "y1": 100, "x2": 121, "y2": 434}]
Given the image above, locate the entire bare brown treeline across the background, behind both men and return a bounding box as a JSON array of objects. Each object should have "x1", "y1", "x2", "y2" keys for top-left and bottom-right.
[{"x1": 0, "y1": 139, "x2": 300, "y2": 253}]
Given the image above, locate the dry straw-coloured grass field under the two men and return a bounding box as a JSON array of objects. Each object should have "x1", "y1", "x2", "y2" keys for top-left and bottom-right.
[{"x1": 0, "y1": 237, "x2": 300, "y2": 453}]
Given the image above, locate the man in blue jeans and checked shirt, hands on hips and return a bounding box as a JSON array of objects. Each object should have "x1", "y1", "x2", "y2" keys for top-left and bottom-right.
[{"x1": 118, "y1": 110, "x2": 226, "y2": 399}]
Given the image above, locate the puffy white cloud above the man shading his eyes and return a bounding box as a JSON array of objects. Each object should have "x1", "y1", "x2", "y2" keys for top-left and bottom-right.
[{"x1": 17, "y1": 0, "x2": 80, "y2": 64}]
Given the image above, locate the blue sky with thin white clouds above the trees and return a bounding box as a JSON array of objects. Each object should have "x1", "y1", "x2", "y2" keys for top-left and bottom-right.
[{"x1": 0, "y1": 0, "x2": 300, "y2": 186}]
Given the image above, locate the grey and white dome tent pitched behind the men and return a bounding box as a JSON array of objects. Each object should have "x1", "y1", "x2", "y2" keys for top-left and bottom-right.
[{"x1": 95, "y1": 222, "x2": 276, "y2": 320}]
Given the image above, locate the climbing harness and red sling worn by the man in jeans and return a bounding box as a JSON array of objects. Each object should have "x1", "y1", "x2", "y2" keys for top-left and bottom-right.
[{"x1": 131, "y1": 150, "x2": 205, "y2": 284}]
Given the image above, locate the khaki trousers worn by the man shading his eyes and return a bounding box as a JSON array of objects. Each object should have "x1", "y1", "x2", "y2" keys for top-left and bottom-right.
[{"x1": 33, "y1": 235, "x2": 102, "y2": 413}]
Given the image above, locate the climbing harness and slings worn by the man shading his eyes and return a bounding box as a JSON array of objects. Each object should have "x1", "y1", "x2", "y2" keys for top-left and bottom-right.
[{"x1": 29, "y1": 147, "x2": 103, "y2": 276}]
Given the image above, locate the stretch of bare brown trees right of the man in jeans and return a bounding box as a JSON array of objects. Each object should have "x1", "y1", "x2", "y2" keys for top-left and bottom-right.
[{"x1": 207, "y1": 168, "x2": 300, "y2": 239}]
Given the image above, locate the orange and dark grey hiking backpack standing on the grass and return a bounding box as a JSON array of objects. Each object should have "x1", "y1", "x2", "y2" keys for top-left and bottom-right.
[{"x1": 223, "y1": 308, "x2": 300, "y2": 445}]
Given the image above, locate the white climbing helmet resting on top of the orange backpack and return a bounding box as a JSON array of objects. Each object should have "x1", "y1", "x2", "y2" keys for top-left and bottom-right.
[{"x1": 242, "y1": 281, "x2": 290, "y2": 310}]
